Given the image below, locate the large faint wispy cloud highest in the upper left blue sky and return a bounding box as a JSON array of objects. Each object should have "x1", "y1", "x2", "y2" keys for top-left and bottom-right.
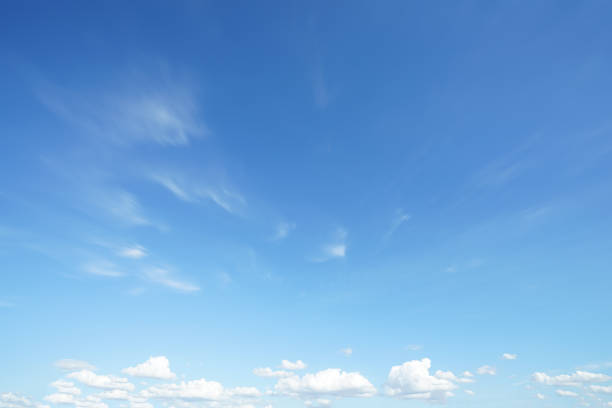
[{"x1": 38, "y1": 75, "x2": 206, "y2": 146}]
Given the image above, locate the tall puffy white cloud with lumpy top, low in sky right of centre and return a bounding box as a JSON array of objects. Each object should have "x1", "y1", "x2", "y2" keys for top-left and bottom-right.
[{"x1": 385, "y1": 358, "x2": 457, "y2": 401}]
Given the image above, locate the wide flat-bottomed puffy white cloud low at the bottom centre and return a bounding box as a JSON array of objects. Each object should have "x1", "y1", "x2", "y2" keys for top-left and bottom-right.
[{"x1": 275, "y1": 368, "x2": 376, "y2": 398}]
